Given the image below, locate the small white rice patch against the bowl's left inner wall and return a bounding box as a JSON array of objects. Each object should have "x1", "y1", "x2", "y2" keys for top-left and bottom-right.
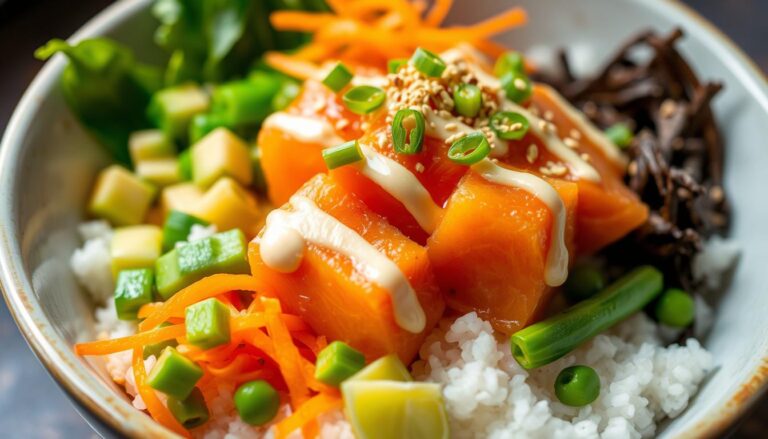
[{"x1": 70, "y1": 221, "x2": 115, "y2": 304}]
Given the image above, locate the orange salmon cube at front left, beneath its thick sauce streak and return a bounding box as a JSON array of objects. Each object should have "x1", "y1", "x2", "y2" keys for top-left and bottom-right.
[{"x1": 249, "y1": 174, "x2": 444, "y2": 364}]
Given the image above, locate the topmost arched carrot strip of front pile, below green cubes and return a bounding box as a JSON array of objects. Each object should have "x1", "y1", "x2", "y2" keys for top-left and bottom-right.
[{"x1": 139, "y1": 274, "x2": 259, "y2": 331}]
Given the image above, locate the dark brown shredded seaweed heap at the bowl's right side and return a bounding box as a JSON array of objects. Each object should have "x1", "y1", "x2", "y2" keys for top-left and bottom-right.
[{"x1": 536, "y1": 29, "x2": 729, "y2": 291}]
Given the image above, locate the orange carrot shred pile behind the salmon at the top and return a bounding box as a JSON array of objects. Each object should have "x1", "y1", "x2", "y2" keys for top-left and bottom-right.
[{"x1": 266, "y1": 0, "x2": 527, "y2": 79}]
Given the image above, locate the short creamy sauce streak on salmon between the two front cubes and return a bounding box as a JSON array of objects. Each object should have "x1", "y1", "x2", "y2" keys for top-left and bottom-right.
[{"x1": 356, "y1": 143, "x2": 442, "y2": 234}]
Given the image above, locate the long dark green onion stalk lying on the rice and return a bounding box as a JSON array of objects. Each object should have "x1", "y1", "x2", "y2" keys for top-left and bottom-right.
[{"x1": 510, "y1": 266, "x2": 664, "y2": 369}]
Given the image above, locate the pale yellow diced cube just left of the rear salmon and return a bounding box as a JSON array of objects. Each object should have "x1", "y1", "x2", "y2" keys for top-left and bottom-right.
[{"x1": 192, "y1": 128, "x2": 252, "y2": 188}]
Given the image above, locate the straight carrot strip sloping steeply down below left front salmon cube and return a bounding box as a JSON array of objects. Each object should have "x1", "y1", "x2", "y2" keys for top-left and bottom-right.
[{"x1": 263, "y1": 299, "x2": 309, "y2": 409}]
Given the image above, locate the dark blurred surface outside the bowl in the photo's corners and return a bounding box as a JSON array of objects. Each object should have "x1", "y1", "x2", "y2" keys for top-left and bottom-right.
[{"x1": 0, "y1": 0, "x2": 768, "y2": 439}]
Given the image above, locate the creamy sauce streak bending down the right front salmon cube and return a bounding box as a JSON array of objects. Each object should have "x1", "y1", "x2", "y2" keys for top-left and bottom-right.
[{"x1": 472, "y1": 159, "x2": 568, "y2": 287}]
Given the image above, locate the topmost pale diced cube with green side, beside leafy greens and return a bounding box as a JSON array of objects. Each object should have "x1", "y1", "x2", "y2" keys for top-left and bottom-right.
[{"x1": 147, "y1": 83, "x2": 210, "y2": 142}]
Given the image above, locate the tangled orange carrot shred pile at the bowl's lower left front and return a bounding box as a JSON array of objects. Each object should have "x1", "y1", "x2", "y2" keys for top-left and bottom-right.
[{"x1": 75, "y1": 274, "x2": 341, "y2": 437}]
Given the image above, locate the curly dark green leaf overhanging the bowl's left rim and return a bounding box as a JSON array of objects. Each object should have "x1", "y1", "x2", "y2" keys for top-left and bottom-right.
[{"x1": 35, "y1": 38, "x2": 162, "y2": 165}]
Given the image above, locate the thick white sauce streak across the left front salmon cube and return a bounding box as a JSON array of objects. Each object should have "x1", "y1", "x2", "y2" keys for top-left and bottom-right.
[{"x1": 257, "y1": 195, "x2": 426, "y2": 333}]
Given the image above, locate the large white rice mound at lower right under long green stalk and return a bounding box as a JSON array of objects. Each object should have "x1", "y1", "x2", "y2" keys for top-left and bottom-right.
[{"x1": 413, "y1": 313, "x2": 713, "y2": 438}]
